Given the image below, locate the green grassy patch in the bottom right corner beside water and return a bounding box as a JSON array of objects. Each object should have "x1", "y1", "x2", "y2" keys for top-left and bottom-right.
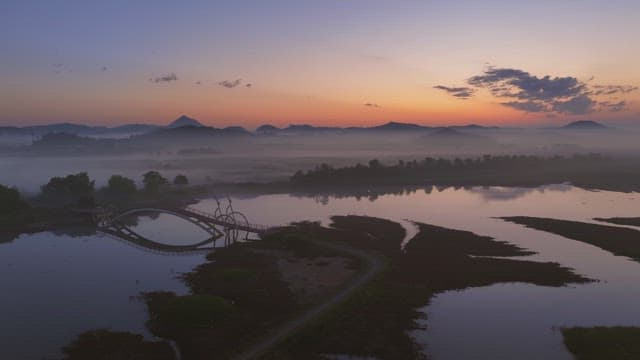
[{"x1": 562, "y1": 326, "x2": 640, "y2": 360}]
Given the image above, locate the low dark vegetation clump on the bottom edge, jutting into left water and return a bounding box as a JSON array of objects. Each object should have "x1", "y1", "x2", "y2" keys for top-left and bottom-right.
[{"x1": 63, "y1": 329, "x2": 175, "y2": 360}]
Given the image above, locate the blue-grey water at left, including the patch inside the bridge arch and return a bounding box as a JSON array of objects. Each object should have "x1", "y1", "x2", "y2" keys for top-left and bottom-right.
[{"x1": 0, "y1": 215, "x2": 206, "y2": 360}]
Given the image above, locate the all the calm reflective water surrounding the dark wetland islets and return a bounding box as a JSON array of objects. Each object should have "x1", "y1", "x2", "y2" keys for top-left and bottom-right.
[{"x1": 0, "y1": 185, "x2": 640, "y2": 359}]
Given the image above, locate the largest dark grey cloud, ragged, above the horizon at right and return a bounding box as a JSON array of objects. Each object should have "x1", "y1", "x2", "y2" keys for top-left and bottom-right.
[{"x1": 435, "y1": 66, "x2": 638, "y2": 115}]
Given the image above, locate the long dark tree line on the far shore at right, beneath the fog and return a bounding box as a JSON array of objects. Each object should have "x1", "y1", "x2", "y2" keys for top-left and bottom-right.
[{"x1": 290, "y1": 154, "x2": 640, "y2": 191}]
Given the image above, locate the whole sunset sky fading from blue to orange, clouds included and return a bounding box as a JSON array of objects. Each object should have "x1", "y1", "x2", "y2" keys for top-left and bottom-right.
[{"x1": 0, "y1": 0, "x2": 640, "y2": 128}]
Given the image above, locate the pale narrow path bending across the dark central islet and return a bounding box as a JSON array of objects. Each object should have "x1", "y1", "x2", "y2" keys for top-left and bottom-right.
[{"x1": 236, "y1": 240, "x2": 384, "y2": 360}]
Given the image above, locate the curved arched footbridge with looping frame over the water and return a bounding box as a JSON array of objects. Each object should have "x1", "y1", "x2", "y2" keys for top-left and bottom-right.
[{"x1": 92, "y1": 202, "x2": 269, "y2": 255}]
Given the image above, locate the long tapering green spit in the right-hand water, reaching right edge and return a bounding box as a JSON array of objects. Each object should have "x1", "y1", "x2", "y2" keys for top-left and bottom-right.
[{"x1": 502, "y1": 216, "x2": 640, "y2": 262}]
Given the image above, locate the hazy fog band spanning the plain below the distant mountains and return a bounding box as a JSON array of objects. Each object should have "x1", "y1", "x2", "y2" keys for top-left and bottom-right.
[{"x1": 0, "y1": 128, "x2": 640, "y2": 192}]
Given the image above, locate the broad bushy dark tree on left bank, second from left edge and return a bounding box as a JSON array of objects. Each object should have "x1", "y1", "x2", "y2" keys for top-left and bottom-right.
[{"x1": 41, "y1": 172, "x2": 94, "y2": 206}]
